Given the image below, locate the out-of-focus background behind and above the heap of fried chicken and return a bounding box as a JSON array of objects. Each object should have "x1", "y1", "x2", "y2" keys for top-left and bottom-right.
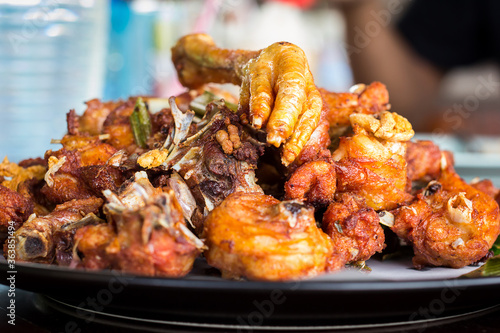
[{"x1": 0, "y1": 0, "x2": 500, "y2": 183}]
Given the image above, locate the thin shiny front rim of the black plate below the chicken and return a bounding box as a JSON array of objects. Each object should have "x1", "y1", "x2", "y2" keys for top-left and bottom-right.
[{"x1": 0, "y1": 261, "x2": 500, "y2": 292}]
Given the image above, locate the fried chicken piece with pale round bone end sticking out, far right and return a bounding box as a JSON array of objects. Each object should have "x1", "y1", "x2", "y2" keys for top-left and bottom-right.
[{"x1": 392, "y1": 165, "x2": 500, "y2": 268}]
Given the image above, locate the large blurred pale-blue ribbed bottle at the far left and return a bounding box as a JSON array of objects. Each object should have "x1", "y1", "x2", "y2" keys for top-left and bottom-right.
[{"x1": 0, "y1": 0, "x2": 109, "y2": 161}]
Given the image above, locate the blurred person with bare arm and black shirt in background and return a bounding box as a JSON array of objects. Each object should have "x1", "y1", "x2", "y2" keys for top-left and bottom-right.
[{"x1": 337, "y1": 0, "x2": 500, "y2": 131}]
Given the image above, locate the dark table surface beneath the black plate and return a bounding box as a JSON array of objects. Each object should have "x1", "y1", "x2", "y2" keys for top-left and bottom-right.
[{"x1": 0, "y1": 285, "x2": 500, "y2": 333}]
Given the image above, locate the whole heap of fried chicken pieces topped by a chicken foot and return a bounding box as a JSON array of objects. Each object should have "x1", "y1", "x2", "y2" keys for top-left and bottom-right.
[{"x1": 0, "y1": 34, "x2": 500, "y2": 280}]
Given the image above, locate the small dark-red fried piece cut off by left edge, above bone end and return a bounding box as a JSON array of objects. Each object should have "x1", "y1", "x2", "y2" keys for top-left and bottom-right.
[{"x1": 0, "y1": 185, "x2": 34, "y2": 232}]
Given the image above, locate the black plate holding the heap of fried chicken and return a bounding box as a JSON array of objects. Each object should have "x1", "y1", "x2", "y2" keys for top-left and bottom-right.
[{"x1": 0, "y1": 260, "x2": 500, "y2": 326}]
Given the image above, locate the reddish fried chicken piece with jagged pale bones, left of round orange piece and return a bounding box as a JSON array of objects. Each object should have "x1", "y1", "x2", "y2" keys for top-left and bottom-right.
[{"x1": 75, "y1": 172, "x2": 203, "y2": 277}]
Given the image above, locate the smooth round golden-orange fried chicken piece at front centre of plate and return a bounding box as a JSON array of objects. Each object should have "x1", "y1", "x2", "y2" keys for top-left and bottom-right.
[{"x1": 205, "y1": 193, "x2": 333, "y2": 281}]
